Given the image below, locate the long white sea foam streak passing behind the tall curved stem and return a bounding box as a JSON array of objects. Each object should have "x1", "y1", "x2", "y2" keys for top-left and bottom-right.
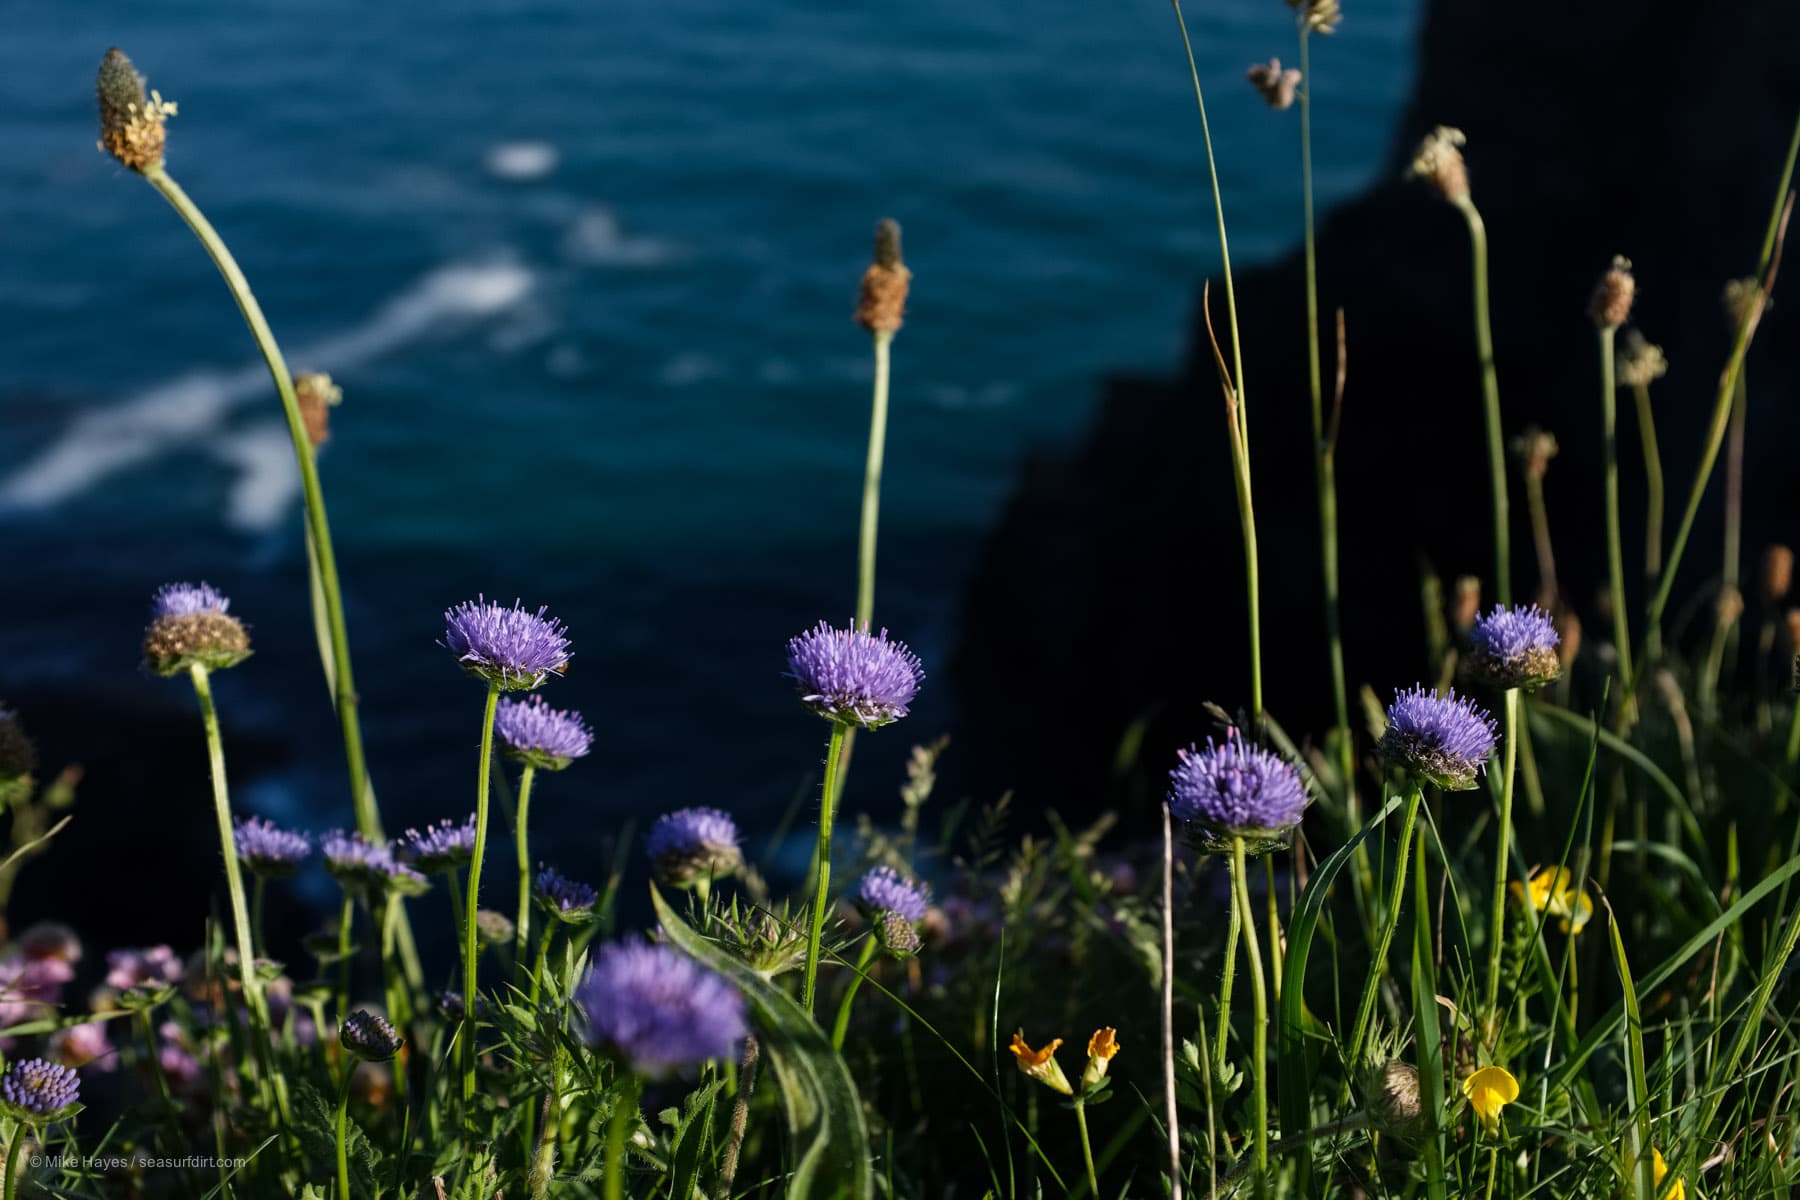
[{"x1": 0, "y1": 263, "x2": 533, "y2": 527}]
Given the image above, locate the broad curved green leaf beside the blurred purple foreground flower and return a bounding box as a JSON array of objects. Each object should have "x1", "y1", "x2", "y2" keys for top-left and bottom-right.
[{"x1": 650, "y1": 885, "x2": 875, "y2": 1200}]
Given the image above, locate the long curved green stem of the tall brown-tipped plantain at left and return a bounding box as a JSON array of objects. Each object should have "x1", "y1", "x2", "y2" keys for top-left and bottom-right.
[{"x1": 144, "y1": 164, "x2": 425, "y2": 988}]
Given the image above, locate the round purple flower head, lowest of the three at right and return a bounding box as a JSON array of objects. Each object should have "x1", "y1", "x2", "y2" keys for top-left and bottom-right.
[{"x1": 1168, "y1": 729, "x2": 1307, "y2": 842}]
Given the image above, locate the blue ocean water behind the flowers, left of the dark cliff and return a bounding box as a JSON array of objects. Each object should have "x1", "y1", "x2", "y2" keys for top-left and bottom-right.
[{"x1": 0, "y1": 0, "x2": 1420, "y2": 862}]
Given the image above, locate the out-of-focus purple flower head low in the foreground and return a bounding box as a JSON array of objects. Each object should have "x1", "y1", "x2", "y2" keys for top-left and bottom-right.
[{"x1": 576, "y1": 939, "x2": 747, "y2": 1078}]
